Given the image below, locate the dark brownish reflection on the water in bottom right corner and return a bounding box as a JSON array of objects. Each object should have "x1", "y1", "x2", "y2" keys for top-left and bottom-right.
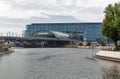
[{"x1": 102, "y1": 66, "x2": 120, "y2": 79}]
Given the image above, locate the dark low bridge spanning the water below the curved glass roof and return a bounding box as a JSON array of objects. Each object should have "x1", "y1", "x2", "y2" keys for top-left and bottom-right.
[{"x1": 0, "y1": 36, "x2": 71, "y2": 48}]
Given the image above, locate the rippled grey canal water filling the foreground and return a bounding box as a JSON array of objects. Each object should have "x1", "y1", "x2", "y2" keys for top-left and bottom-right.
[{"x1": 0, "y1": 48, "x2": 120, "y2": 79}]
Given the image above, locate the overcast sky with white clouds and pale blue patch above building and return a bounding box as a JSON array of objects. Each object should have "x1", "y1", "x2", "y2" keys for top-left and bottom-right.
[{"x1": 0, "y1": 0, "x2": 119, "y2": 33}]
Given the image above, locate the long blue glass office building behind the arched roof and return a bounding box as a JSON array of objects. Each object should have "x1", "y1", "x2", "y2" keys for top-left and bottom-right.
[{"x1": 26, "y1": 23, "x2": 102, "y2": 41}]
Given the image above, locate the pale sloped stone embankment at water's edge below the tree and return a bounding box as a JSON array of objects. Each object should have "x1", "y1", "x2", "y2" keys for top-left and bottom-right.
[{"x1": 95, "y1": 51, "x2": 120, "y2": 62}]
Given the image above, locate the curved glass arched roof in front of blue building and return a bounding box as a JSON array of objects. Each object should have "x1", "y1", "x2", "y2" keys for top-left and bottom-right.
[{"x1": 32, "y1": 30, "x2": 69, "y2": 38}]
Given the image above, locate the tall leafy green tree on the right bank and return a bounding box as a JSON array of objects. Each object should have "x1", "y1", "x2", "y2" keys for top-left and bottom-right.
[{"x1": 102, "y1": 3, "x2": 120, "y2": 49}]
